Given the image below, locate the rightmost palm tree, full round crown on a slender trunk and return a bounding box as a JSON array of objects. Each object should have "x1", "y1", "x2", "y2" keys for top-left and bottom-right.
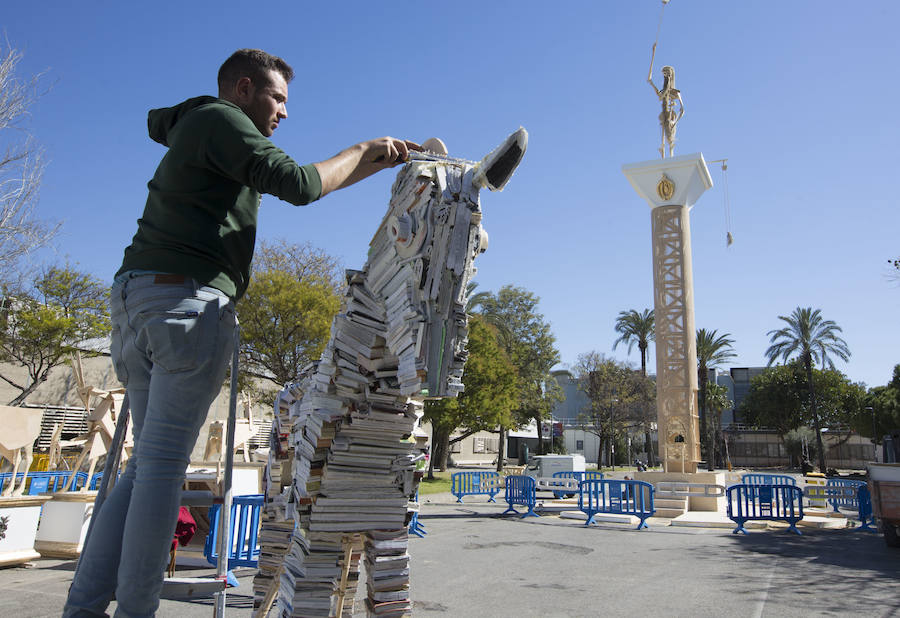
[{"x1": 766, "y1": 307, "x2": 850, "y2": 473}]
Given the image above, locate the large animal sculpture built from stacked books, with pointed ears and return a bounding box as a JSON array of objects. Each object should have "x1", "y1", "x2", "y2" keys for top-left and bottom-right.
[{"x1": 254, "y1": 129, "x2": 528, "y2": 616}]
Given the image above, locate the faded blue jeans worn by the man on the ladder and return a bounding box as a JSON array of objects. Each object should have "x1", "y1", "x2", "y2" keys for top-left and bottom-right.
[{"x1": 63, "y1": 274, "x2": 235, "y2": 617}]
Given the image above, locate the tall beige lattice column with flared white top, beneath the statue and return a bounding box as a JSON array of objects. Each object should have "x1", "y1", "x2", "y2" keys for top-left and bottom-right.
[{"x1": 622, "y1": 153, "x2": 712, "y2": 473}]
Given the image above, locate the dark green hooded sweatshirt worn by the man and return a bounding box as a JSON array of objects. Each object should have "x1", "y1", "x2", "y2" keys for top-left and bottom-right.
[{"x1": 117, "y1": 96, "x2": 322, "y2": 300}]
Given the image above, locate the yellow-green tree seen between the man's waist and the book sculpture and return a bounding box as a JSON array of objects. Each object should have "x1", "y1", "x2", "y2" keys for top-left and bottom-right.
[{"x1": 237, "y1": 241, "x2": 342, "y2": 399}]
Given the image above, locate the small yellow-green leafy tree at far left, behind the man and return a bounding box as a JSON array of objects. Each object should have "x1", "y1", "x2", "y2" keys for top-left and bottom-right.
[{"x1": 0, "y1": 265, "x2": 110, "y2": 406}]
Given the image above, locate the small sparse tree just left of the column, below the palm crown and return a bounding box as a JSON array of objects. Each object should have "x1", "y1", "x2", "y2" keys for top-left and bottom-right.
[{"x1": 573, "y1": 352, "x2": 656, "y2": 468}]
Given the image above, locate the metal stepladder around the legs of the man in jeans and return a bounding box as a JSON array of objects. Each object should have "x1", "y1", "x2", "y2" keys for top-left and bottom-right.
[{"x1": 76, "y1": 323, "x2": 241, "y2": 618}]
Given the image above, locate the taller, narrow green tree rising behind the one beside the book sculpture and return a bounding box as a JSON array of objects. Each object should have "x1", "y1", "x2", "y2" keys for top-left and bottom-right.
[{"x1": 481, "y1": 285, "x2": 562, "y2": 460}]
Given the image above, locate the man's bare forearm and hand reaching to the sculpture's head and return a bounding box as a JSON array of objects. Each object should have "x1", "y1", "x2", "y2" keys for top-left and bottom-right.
[{"x1": 313, "y1": 137, "x2": 422, "y2": 196}]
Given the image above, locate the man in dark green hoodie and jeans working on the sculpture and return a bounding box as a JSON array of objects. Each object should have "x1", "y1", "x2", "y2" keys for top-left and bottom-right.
[{"x1": 63, "y1": 49, "x2": 420, "y2": 617}]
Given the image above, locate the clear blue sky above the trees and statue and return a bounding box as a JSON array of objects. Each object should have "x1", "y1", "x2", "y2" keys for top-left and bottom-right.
[{"x1": 7, "y1": 0, "x2": 900, "y2": 386}]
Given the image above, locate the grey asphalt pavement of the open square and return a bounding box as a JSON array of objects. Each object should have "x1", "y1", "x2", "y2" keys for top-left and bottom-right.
[{"x1": 0, "y1": 494, "x2": 900, "y2": 618}]
